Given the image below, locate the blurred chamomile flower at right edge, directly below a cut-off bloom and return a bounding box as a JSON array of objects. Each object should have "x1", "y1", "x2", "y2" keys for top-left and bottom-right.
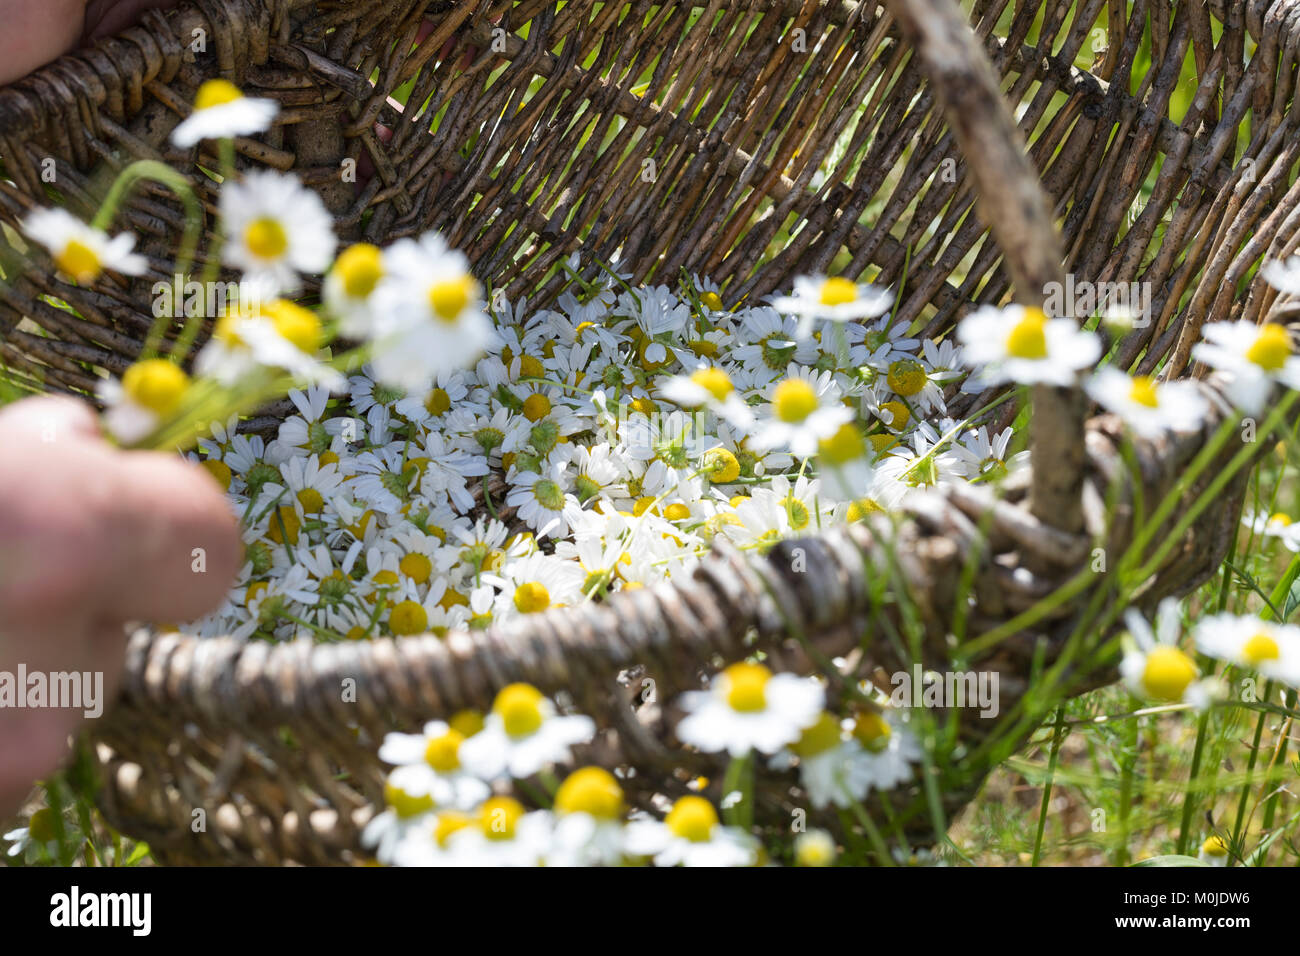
[{"x1": 1192, "y1": 319, "x2": 1300, "y2": 415}]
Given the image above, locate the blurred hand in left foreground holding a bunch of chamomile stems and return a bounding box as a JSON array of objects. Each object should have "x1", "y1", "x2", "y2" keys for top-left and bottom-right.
[{"x1": 0, "y1": 398, "x2": 242, "y2": 818}]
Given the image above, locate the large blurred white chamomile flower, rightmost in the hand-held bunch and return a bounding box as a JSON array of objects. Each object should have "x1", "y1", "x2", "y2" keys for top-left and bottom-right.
[{"x1": 371, "y1": 233, "x2": 493, "y2": 394}]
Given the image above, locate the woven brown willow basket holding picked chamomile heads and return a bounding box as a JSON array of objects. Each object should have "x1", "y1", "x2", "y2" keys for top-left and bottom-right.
[{"x1": 0, "y1": 0, "x2": 1300, "y2": 864}]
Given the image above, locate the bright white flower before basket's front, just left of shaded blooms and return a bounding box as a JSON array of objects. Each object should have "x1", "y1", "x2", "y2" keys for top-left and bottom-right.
[{"x1": 677, "y1": 662, "x2": 824, "y2": 757}]
